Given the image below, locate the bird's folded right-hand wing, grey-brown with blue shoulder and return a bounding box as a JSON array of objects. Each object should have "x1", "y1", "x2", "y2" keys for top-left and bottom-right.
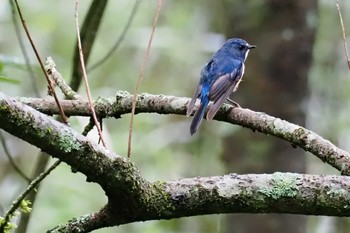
[{"x1": 207, "y1": 61, "x2": 244, "y2": 120}]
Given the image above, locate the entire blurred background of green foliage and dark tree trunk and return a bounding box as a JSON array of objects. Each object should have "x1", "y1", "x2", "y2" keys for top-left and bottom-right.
[{"x1": 0, "y1": 0, "x2": 350, "y2": 233}]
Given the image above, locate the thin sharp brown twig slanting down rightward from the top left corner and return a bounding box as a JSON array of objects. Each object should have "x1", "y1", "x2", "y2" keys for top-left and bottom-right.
[{"x1": 14, "y1": 0, "x2": 67, "y2": 124}]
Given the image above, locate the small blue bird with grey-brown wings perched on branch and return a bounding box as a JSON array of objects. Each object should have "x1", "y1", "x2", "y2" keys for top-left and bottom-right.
[{"x1": 186, "y1": 38, "x2": 256, "y2": 135}]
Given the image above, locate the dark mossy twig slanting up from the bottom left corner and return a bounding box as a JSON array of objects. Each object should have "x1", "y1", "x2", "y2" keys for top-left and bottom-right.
[{"x1": 0, "y1": 160, "x2": 61, "y2": 232}]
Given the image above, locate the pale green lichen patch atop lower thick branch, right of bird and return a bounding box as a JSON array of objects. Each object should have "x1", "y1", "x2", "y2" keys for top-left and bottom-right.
[{"x1": 259, "y1": 172, "x2": 299, "y2": 200}]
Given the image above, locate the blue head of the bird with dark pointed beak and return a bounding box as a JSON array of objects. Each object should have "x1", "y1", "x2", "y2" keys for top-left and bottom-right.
[{"x1": 222, "y1": 38, "x2": 256, "y2": 60}]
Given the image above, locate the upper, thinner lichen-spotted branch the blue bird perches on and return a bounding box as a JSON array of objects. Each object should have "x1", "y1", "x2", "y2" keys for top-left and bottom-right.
[{"x1": 18, "y1": 92, "x2": 350, "y2": 175}]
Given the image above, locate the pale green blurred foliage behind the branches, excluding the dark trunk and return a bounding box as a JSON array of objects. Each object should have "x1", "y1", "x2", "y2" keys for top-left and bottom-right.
[{"x1": 0, "y1": 0, "x2": 350, "y2": 233}]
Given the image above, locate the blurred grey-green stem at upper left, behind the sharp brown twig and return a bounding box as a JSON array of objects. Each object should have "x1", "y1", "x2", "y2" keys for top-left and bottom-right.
[{"x1": 9, "y1": 0, "x2": 40, "y2": 97}]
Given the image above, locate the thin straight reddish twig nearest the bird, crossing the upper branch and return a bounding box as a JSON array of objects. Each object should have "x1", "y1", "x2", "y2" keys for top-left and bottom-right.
[{"x1": 128, "y1": 0, "x2": 162, "y2": 158}]
